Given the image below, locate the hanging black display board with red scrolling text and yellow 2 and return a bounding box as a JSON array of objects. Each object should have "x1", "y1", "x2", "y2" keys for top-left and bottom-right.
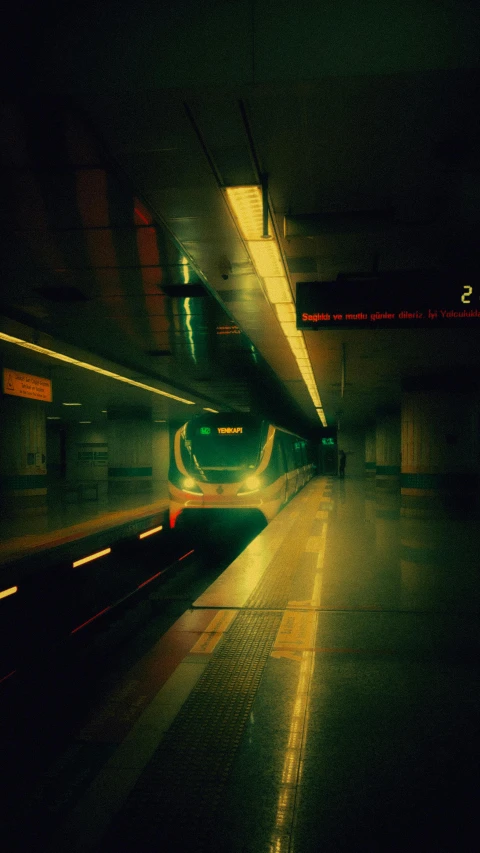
[{"x1": 297, "y1": 274, "x2": 480, "y2": 329}]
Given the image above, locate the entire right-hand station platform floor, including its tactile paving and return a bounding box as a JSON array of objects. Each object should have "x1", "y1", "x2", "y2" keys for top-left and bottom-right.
[{"x1": 14, "y1": 477, "x2": 480, "y2": 853}]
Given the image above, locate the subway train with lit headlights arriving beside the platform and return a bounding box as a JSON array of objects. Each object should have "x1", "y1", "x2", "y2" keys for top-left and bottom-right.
[{"x1": 169, "y1": 412, "x2": 316, "y2": 529}]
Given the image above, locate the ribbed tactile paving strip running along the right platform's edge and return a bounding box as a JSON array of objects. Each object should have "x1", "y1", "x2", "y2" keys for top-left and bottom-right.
[{"x1": 49, "y1": 479, "x2": 334, "y2": 853}]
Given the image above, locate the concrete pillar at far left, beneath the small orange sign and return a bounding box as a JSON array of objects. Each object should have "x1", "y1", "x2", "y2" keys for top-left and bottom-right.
[{"x1": 0, "y1": 395, "x2": 47, "y2": 514}]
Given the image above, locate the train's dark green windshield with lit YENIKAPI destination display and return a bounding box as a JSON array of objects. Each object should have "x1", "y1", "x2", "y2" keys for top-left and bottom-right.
[{"x1": 192, "y1": 420, "x2": 261, "y2": 471}]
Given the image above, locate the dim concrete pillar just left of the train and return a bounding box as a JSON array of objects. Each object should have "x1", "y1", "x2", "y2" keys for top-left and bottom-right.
[{"x1": 108, "y1": 407, "x2": 153, "y2": 495}]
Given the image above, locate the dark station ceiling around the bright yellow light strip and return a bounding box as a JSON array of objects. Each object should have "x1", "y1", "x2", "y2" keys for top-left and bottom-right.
[{"x1": 0, "y1": 0, "x2": 480, "y2": 431}]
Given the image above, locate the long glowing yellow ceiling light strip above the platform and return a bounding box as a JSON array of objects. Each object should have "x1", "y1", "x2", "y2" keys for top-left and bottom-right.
[{"x1": 225, "y1": 186, "x2": 327, "y2": 427}]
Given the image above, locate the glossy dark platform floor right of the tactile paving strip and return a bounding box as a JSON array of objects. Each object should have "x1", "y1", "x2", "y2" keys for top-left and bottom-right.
[{"x1": 210, "y1": 479, "x2": 480, "y2": 853}]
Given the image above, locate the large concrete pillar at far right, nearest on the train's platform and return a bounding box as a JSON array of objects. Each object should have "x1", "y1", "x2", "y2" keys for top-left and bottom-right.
[{"x1": 401, "y1": 382, "x2": 479, "y2": 518}]
